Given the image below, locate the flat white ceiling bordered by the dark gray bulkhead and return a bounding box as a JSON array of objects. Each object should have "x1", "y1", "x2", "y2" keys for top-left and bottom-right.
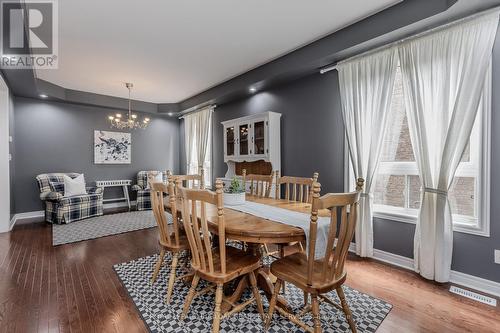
[{"x1": 37, "y1": 0, "x2": 400, "y2": 103}]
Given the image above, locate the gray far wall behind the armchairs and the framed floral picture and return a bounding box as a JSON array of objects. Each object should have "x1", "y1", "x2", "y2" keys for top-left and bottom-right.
[{"x1": 13, "y1": 97, "x2": 179, "y2": 213}]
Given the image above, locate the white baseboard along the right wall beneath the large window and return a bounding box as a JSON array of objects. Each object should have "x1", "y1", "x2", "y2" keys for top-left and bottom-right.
[{"x1": 349, "y1": 243, "x2": 500, "y2": 297}]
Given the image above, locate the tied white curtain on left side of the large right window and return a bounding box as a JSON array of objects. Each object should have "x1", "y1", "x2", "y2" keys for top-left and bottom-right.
[{"x1": 337, "y1": 48, "x2": 397, "y2": 257}]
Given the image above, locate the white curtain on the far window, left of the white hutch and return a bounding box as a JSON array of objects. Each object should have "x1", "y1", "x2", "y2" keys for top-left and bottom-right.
[{"x1": 184, "y1": 106, "x2": 214, "y2": 186}]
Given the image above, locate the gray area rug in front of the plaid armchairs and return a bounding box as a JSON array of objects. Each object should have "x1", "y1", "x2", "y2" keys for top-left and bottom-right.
[{"x1": 52, "y1": 211, "x2": 163, "y2": 246}]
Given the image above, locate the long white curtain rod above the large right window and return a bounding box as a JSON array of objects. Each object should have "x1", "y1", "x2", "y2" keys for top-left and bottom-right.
[{"x1": 319, "y1": 6, "x2": 500, "y2": 74}]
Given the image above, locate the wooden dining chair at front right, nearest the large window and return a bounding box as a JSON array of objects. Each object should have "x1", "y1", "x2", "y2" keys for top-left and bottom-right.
[{"x1": 266, "y1": 183, "x2": 360, "y2": 333}]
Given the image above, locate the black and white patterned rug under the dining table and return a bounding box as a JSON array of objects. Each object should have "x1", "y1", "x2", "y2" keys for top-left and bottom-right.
[{"x1": 113, "y1": 255, "x2": 392, "y2": 333}]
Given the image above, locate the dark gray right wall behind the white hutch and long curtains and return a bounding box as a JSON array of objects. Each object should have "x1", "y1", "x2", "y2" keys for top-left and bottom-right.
[{"x1": 193, "y1": 27, "x2": 500, "y2": 282}]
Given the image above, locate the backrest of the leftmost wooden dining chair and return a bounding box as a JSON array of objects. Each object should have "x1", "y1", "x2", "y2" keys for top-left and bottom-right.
[{"x1": 151, "y1": 182, "x2": 179, "y2": 246}]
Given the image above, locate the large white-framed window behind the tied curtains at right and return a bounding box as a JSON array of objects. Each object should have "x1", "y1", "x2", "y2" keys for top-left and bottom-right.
[{"x1": 349, "y1": 67, "x2": 491, "y2": 236}]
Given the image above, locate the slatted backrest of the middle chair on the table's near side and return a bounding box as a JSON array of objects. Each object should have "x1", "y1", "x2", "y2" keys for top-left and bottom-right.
[{"x1": 178, "y1": 180, "x2": 226, "y2": 274}]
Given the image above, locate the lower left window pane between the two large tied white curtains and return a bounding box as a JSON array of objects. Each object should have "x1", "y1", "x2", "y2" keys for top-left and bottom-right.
[{"x1": 373, "y1": 175, "x2": 405, "y2": 207}]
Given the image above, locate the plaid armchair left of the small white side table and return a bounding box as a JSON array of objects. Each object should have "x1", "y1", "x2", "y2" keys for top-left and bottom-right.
[{"x1": 36, "y1": 173, "x2": 103, "y2": 224}]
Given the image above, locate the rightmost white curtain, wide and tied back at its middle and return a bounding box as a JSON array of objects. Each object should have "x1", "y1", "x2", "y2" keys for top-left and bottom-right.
[{"x1": 399, "y1": 12, "x2": 499, "y2": 282}]
